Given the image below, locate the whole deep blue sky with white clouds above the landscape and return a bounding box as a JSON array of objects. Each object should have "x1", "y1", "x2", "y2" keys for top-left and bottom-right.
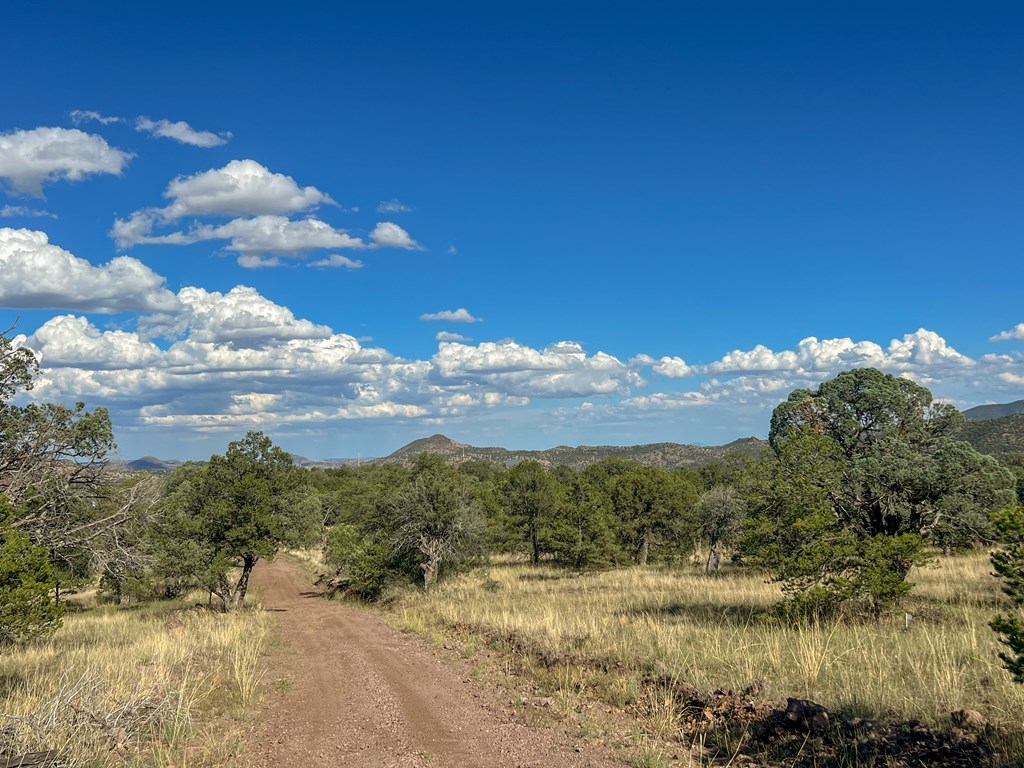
[{"x1": 0, "y1": 2, "x2": 1024, "y2": 458}]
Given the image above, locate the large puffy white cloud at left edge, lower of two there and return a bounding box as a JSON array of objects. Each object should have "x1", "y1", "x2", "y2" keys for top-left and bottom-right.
[{"x1": 0, "y1": 227, "x2": 178, "y2": 312}]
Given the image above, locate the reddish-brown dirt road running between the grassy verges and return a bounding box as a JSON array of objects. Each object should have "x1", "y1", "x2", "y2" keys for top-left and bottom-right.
[{"x1": 241, "y1": 560, "x2": 623, "y2": 768}]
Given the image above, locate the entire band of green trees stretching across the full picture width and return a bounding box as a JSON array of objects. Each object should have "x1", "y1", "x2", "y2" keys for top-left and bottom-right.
[{"x1": 6, "y1": 321, "x2": 1024, "y2": 674}]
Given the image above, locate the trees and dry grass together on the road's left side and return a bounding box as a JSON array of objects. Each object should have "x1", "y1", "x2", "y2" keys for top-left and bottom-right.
[{"x1": 0, "y1": 335, "x2": 307, "y2": 768}]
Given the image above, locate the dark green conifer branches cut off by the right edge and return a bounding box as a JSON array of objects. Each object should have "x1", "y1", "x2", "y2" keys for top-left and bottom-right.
[{"x1": 990, "y1": 505, "x2": 1024, "y2": 683}]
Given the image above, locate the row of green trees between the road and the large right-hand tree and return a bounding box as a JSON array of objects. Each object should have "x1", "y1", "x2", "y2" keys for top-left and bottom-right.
[{"x1": 310, "y1": 454, "x2": 750, "y2": 598}]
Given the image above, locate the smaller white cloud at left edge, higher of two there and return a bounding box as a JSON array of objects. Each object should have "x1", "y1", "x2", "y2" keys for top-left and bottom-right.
[{"x1": 0, "y1": 127, "x2": 132, "y2": 198}]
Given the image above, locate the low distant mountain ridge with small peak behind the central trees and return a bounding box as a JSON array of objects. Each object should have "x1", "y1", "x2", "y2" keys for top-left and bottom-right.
[{"x1": 377, "y1": 434, "x2": 768, "y2": 471}]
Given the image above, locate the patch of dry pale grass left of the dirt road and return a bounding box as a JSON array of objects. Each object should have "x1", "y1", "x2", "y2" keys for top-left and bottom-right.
[{"x1": 0, "y1": 603, "x2": 272, "y2": 768}]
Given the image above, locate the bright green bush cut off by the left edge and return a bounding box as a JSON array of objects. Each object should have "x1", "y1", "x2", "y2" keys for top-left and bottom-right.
[{"x1": 0, "y1": 497, "x2": 63, "y2": 646}]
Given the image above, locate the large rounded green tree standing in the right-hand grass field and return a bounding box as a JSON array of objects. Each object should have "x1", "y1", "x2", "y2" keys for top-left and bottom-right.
[{"x1": 740, "y1": 369, "x2": 1013, "y2": 613}]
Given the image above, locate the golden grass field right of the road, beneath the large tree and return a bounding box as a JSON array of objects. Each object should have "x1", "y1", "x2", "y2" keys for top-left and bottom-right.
[{"x1": 398, "y1": 552, "x2": 1024, "y2": 730}]
